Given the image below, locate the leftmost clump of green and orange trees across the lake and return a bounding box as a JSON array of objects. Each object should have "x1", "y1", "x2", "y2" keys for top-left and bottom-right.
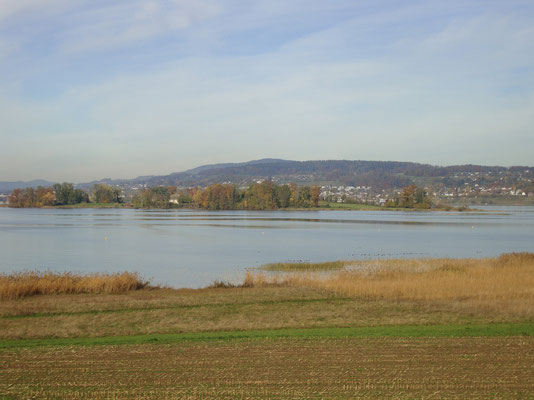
[{"x1": 8, "y1": 182, "x2": 122, "y2": 208}]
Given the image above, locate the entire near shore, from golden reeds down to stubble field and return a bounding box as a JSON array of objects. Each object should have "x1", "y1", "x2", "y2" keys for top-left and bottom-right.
[{"x1": 0, "y1": 253, "x2": 534, "y2": 399}]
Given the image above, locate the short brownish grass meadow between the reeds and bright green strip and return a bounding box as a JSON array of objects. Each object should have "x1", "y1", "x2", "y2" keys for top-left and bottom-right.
[{"x1": 0, "y1": 287, "x2": 490, "y2": 339}]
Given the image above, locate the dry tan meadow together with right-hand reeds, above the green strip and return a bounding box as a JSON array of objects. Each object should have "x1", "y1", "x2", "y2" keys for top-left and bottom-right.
[{"x1": 0, "y1": 253, "x2": 534, "y2": 339}]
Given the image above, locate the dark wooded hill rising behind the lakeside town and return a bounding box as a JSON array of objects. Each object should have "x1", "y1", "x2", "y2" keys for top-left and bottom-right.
[{"x1": 81, "y1": 159, "x2": 534, "y2": 189}]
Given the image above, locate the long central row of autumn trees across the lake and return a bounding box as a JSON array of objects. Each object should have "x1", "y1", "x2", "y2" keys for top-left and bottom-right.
[{"x1": 133, "y1": 181, "x2": 321, "y2": 210}]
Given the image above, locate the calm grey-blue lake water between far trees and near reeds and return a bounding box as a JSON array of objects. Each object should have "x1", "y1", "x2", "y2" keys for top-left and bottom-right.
[{"x1": 0, "y1": 207, "x2": 534, "y2": 287}]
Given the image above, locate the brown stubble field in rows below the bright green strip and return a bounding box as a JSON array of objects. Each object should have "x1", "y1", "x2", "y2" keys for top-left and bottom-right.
[{"x1": 0, "y1": 336, "x2": 534, "y2": 399}]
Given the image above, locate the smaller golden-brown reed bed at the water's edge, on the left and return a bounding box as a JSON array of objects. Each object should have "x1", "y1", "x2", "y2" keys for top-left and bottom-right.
[{"x1": 0, "y1": 271, "x2": 149, "y2": 300}]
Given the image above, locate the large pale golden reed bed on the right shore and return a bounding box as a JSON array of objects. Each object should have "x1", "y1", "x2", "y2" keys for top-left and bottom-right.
[{"x1": 244, "y1": 253, "x2": 534, "y2": 317}]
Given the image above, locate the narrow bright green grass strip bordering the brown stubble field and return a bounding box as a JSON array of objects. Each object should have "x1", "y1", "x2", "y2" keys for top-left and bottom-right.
[{"x1": 0, "y1": 323, "x2": 534, "y2": 349}]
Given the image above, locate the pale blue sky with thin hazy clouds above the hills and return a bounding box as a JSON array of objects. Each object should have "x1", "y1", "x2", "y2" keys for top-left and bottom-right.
[{"x1": 0, "y1": 0, "x2": 534, "y2": 182}]
